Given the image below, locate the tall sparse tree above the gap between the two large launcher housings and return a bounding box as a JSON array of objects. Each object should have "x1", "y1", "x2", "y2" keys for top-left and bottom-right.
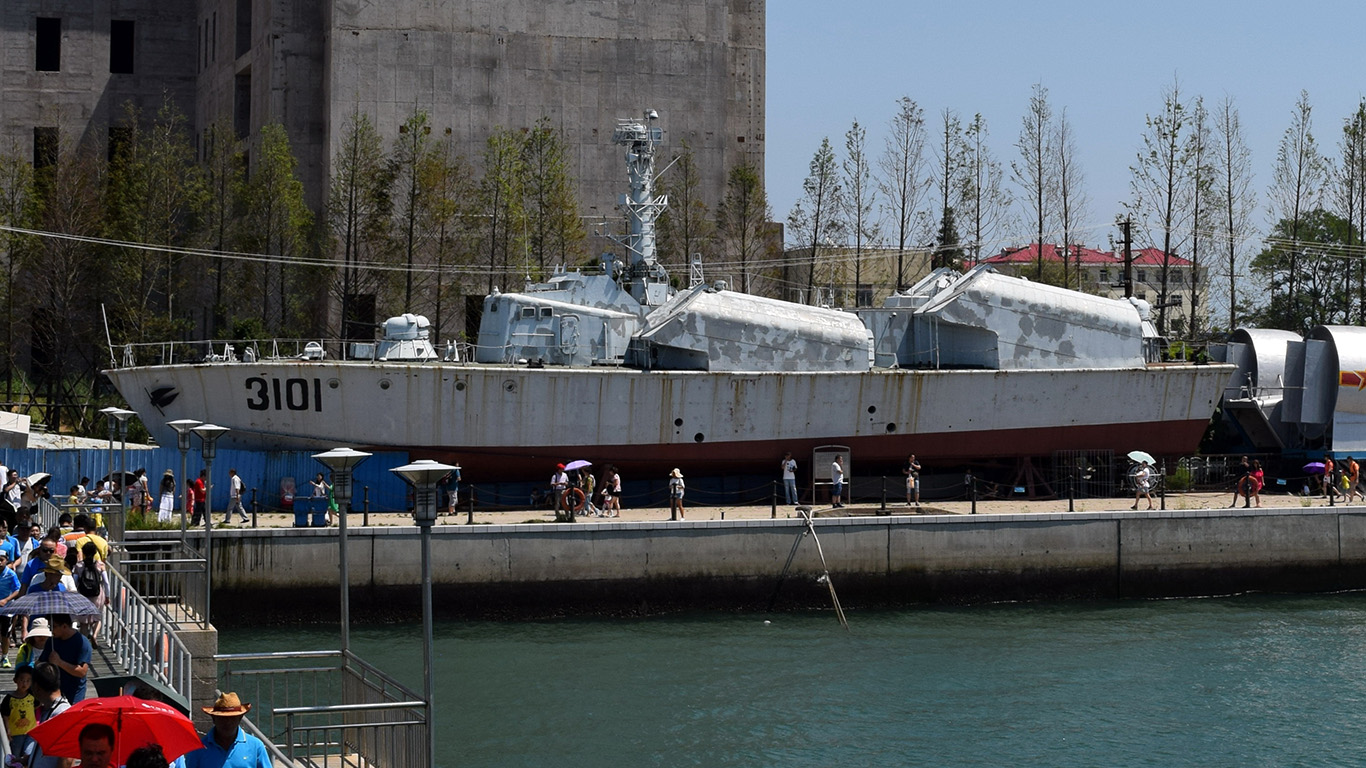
[{"x1": 878, "y1": 96, "x2": 929, "y2": 291}]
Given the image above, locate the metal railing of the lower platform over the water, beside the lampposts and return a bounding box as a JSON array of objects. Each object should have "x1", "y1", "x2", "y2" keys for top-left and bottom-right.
[{"x1": 214, "y1": 650, "x2": 430, "y2": 768}]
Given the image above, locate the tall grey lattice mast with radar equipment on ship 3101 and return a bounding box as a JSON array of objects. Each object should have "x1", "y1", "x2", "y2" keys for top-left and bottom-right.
[{"x1": 612, "y1": 109, "x2": 671, "y2": 306}]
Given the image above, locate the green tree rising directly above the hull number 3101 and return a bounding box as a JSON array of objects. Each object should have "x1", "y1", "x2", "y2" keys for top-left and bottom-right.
[{"x1": 240, "y1": 123, "x2": 315, "y2": 333}]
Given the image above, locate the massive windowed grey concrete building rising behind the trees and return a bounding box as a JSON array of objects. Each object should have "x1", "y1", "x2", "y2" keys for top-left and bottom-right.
[{"x1": 0, "y1": 0, "x2": 765, "y2": 226}]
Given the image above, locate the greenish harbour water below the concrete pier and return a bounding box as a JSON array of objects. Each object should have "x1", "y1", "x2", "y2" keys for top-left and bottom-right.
[{"x1": 220, "y1": 594, "x2": 1366, "y2": 768}]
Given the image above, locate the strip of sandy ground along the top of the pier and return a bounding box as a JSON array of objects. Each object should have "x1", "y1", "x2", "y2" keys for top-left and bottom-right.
[{"x1": 214, "y1": 492, "x2": 1349, "y2": 529}]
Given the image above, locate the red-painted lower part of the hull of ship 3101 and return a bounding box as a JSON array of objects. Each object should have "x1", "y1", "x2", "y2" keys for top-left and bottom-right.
[{"x1": 393, "y1": 420, "x2": 1208, "y2": 482}]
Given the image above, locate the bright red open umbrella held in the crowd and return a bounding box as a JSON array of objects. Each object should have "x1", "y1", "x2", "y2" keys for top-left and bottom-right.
[{"x1": 29, "y1": 696, "x2": 204, "y2": 765}]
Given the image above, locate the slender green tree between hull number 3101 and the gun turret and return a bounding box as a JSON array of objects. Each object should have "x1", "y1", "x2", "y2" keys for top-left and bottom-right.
[{"x1": 328, "y1": 109, "x2": 393, "y2": 339}]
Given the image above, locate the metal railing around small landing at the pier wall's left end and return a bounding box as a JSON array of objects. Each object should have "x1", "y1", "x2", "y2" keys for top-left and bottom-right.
[{"x1": 111, "y1": 538, "x2": 209, "y2": 629}]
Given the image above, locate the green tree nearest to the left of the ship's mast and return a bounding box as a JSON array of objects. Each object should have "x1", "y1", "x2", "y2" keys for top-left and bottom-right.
[{"x1": 522, "y1": 118, "x2": 587, "y2": 273}]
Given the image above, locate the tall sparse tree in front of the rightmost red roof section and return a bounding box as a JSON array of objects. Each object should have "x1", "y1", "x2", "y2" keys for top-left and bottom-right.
[{"x1": 1130, "y1": 81, "x2": 1190, "y2": 333}]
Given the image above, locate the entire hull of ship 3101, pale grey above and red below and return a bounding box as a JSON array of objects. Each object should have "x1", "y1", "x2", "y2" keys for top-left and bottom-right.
[{"x1": 108, "y1": 359, "x2": 1232, "y2": 480}]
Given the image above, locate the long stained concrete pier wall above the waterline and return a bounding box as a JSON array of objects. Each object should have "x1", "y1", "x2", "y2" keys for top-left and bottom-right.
[{"x1": 155, "y1": 507, "x2": 1366, "y2": 618}]
